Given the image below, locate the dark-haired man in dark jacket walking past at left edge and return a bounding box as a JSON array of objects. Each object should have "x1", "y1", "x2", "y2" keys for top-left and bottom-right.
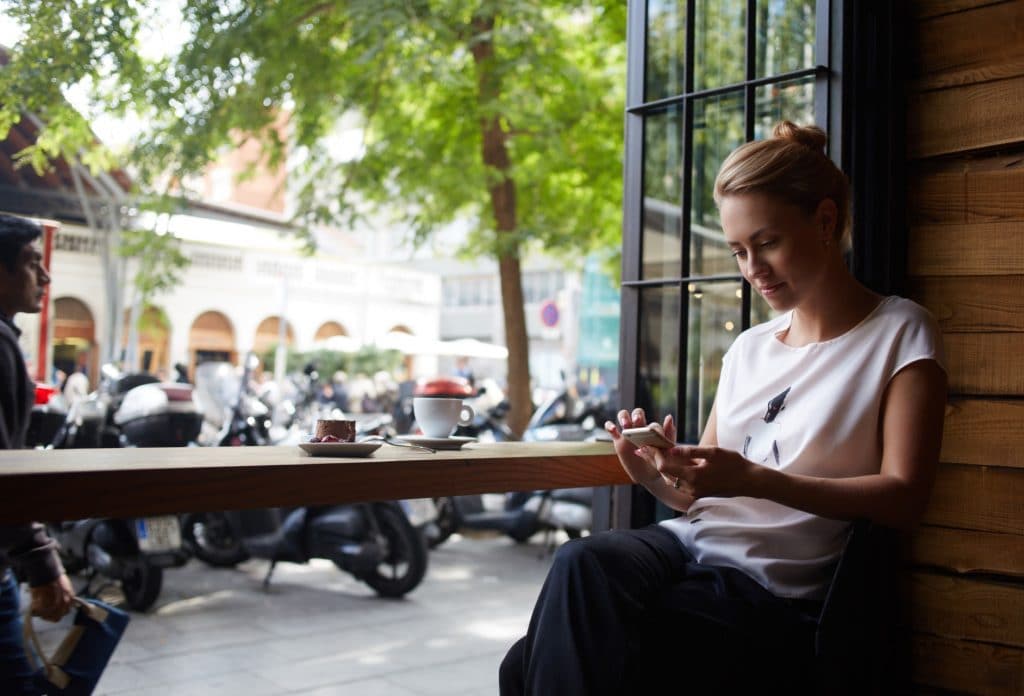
[{"x1": 0, "y1": 215, "x2": 75, "y2": 696}]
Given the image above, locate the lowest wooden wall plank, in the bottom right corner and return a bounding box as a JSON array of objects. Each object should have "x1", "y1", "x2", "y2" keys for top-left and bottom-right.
[{"x1": 910, "y1": 634, "x2": 1024, "y2": 696}]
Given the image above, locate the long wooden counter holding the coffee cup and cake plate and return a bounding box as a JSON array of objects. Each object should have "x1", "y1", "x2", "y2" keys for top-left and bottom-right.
[{"x1": 0, "y1": 442, "x2": 629, "y2": 524}]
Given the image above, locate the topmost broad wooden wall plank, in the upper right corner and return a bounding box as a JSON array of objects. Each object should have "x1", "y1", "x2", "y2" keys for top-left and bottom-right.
[{"x1": 911, "y1": 2, "x2": 1024, "y2": 90}]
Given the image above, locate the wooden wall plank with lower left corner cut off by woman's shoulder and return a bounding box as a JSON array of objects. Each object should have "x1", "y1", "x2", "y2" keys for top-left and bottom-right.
[{"x1": 907, "y1": 275, "x2": 1024, "y2": 334}]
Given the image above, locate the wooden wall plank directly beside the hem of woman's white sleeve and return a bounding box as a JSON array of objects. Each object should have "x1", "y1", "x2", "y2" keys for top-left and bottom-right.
[{"x1": 943, "y1": 333, "x2": 1024, "y2": 396}]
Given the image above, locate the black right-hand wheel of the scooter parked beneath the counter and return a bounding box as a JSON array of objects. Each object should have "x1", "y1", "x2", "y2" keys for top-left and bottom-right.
[{"x1": 361, "y1": 506, "x2": 427, "y2": 599}]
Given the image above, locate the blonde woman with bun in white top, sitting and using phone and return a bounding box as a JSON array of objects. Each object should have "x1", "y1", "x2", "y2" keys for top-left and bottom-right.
[{"x1": 501, "y1": 122, "x2": 946, "y2": 695}]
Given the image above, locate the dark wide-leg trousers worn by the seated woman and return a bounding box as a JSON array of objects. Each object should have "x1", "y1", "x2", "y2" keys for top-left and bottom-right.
[{"x1": 499, "y1": 525, "x2": 820, "y2": 696}]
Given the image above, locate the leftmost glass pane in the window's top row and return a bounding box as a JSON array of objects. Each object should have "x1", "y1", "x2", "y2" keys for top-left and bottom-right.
[{"x1": 644, "y1": 0, "x2": 686, "y2": 101}]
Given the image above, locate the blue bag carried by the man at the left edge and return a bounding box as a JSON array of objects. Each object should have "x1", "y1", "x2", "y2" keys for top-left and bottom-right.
[{"x1": 25, "y1": 598, "x2": 128, "y2": 696}]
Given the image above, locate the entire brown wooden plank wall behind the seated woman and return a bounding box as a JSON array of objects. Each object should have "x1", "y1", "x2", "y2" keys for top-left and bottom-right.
[{"x1": 906, "y1": 0, "x2": 1024, "y2": 694}]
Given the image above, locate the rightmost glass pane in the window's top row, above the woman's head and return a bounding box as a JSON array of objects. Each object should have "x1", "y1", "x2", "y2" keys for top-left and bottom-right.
[{"x1": 756, "y1": 0, "x2": 816, "y2": 77}]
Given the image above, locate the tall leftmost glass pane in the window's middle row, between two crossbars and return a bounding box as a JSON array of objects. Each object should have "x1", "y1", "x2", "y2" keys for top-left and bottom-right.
[{"x1": 640, "y1": 107, "x2": 683, "y2": 278}]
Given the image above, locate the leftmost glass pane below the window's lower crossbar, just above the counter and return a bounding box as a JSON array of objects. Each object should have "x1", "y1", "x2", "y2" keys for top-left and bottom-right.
[{"x1": 638, "y1": 286, "x2": 681, "y2": 421}]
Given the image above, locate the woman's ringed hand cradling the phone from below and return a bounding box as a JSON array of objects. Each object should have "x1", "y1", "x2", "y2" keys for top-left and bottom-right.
[{"x1": 640, "y1": 444, "x2": 759, "y2": 498}]
